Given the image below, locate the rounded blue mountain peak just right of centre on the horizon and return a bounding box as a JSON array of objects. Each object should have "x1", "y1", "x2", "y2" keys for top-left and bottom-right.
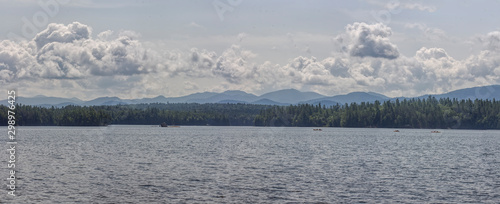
[{"x1": 259, "y1": 89, "x2": 325, "y2": 104}]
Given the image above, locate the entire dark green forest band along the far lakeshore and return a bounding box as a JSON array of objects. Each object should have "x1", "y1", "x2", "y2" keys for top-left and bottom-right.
[{"x1": 0, "y1": 97, "x2": 500, "y2": 129}]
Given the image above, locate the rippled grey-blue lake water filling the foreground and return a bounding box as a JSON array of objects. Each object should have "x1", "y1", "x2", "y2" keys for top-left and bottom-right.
[{"x1": 0, "y1": 126, "x2": 500, "y2": 203}]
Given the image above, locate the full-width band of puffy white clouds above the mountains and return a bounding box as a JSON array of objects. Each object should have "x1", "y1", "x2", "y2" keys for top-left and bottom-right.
[{"x1": 0, "y1": 22, "x2": 500, "y2": 98}]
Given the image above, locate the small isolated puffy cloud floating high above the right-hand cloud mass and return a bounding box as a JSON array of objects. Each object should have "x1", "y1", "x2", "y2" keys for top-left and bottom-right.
[{"x1": 338, "y1": 22, "x2": 399, "y2": 59}]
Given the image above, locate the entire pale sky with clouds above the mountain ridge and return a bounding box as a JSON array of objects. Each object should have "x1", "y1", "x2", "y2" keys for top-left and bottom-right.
[{"x1": 0, "y1": 0, "x2": 500, "y2": 100}]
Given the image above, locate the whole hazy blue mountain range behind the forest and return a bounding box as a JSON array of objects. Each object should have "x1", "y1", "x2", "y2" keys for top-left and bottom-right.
[{"x1": 4, "y1": 85, "x2": 500, "y2": 107}]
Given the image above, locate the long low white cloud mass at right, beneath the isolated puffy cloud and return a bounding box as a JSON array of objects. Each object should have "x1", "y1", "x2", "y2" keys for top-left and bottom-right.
[{"x1": 262, "y1": 41, "x2": 500, "y2": 96}]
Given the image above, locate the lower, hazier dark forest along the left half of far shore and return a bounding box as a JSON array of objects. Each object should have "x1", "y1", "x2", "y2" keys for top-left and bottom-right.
[{"x1": 0, "y1": 103, "x2": 270, "y2": 126}]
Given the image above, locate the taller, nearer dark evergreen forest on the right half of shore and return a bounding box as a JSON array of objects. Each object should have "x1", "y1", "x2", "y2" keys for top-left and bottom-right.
[{"x1": 255, "y1": 97, "x2": 500, "y2": 129}]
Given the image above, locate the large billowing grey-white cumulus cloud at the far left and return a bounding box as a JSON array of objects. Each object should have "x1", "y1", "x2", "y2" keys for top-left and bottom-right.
[{"x1": 0, "y1": 22, "x2": 157, "y2": 80}]
